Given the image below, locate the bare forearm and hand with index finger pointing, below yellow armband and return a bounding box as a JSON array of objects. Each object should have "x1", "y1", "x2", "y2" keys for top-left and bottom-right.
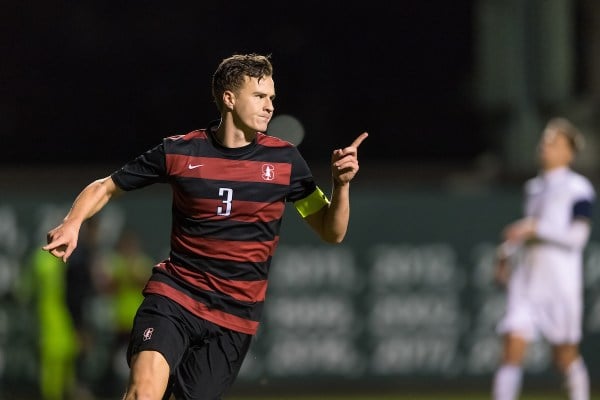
[{"x1": 305, "y1": 132, "x2": 369, "y2": 243}]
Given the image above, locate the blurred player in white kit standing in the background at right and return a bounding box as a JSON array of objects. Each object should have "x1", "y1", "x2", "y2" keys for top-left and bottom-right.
[{"x1": 492, "y1": 118, "x2": 595, "y2": 400}]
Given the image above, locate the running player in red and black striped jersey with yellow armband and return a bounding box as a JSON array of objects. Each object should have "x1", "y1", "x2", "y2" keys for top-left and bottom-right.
[{"x1": 43, "y1": 54, "x2": 368, "y2": 400}]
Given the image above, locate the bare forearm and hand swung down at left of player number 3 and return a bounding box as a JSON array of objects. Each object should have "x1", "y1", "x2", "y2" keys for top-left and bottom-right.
[{"x1": 42, "y1": 177, "x2": 121, "y2": 262}]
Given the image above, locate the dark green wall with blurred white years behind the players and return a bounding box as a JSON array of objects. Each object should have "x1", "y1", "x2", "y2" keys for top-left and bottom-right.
[{"x1": 0, "y1": 177, "x2": 600, "y2": 393}]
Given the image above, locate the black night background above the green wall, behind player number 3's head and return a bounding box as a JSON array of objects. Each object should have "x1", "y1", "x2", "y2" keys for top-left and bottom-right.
[{"x1": 0, "y1": 0, "x2": 482, "y2": 165}]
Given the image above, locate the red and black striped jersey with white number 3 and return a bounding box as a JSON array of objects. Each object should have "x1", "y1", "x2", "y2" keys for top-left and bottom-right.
[{"x1": 112, "y1": 122, "x2": 316, "y2": 334}]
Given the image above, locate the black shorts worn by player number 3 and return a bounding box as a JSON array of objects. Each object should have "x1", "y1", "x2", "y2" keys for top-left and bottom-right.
[{"x1": 127, "y1": 295, "x2": 252, "y2": 400}]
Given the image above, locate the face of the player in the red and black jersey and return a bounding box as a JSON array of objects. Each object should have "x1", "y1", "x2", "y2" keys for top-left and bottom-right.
[{"x1": 234, "y1": 76, "x2": 275, "y2": 133}]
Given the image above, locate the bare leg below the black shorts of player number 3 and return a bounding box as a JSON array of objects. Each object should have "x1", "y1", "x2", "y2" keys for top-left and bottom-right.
[{"x1": 125, "y1": 350, "x2": 169, "y2": 400}]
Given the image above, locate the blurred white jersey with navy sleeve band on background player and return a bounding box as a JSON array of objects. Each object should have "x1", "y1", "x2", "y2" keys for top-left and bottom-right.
[{"x1": 519, "y1": 168, "x2": 595, "y2": 300}]
